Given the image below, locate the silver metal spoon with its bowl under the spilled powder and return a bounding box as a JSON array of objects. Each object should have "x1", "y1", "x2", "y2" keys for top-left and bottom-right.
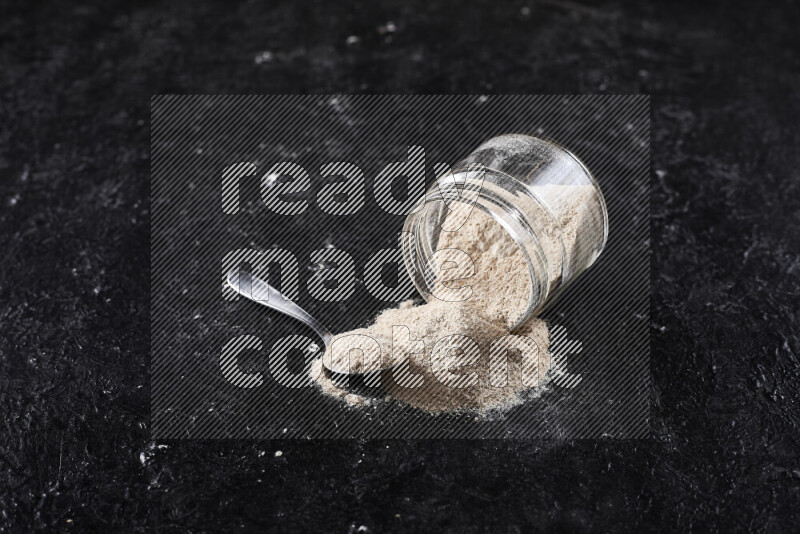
[{"x1": 226, "y1": 267, "x2": 391, "y2": 387}]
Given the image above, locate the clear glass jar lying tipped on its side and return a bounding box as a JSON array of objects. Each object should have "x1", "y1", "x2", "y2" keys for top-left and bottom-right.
[{"x1": 402, "y1": 134, "x2": 608, "y2": 330}]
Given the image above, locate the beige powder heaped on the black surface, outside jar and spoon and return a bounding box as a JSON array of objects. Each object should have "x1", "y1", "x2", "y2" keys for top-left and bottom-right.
[{"x1": 312, "y1": 302, "x2": 550, "y2": 413}]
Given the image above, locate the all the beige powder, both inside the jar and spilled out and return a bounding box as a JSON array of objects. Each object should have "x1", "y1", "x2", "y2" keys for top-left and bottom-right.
[{"x1": 311, "y1": 170, "x2": 604, "y2": 413}]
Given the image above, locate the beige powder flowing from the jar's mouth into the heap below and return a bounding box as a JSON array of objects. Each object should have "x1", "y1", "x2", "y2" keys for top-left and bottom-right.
[{"x1": 310, "y1": 209, "x2": 550, "y2": 413}]
